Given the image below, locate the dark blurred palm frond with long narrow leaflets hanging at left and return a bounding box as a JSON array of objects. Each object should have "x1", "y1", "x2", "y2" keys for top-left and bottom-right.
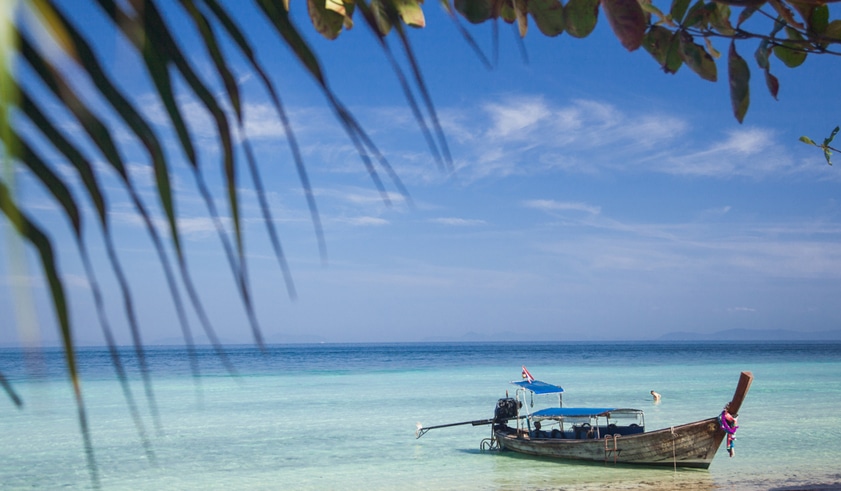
[{"x1": 0, "y1": 0, "x2": 452, "y2": 487}]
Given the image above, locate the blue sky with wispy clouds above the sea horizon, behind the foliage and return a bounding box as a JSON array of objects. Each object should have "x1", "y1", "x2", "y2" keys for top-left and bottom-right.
[{"x1": 0, "y1": 2, "x2": 841, "y2": 344}]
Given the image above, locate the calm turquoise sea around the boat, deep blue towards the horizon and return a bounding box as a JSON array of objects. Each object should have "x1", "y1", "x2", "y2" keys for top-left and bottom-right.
[{"x1": 0, "y1": 343, "x2": 841, "y2": 490}]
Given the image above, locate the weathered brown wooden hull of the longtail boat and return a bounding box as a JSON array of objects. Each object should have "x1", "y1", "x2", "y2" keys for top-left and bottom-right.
[{"x1": 494, "y1": 418, "x2": 724, "y2": 469}]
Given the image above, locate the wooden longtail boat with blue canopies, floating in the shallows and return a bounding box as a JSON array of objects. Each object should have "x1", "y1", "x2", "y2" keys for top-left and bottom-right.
[{"x1": 416, "y1": 367, "x2": 753, "y2": 469}]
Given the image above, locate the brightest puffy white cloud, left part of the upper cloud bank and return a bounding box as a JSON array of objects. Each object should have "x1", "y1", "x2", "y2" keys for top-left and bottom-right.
[{"x1": 440, "y1": 96, "x2": 689, "y2": 180}]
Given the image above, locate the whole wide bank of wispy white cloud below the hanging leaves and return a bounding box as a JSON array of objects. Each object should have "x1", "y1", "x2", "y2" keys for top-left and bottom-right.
[{"x1": 426, "y1": 95, "x2": 828, "y2": 182}]
